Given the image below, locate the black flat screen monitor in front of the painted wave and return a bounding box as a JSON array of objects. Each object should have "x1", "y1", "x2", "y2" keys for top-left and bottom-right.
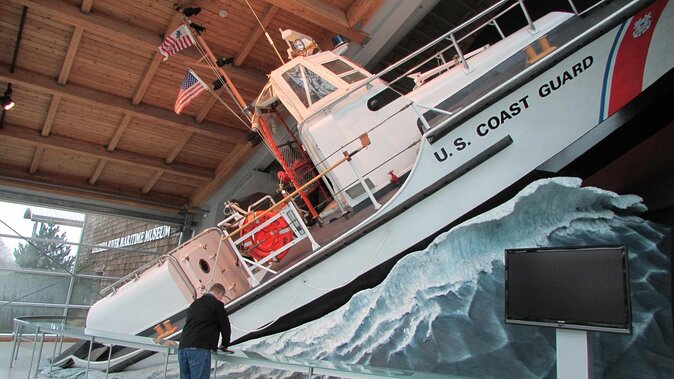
[{"x1": 505, "y1": 245, "x2": 632, "y2": 334}]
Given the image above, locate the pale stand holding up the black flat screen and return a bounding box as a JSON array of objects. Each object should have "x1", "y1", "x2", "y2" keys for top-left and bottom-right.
[{"x1": 556, "y1": 329, "x2": 592, "y2": 379}]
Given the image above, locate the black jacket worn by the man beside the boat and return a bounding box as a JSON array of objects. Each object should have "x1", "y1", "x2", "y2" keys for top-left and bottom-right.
[{"x1": 179, "y1": 293, "x2": 232, "y2": 350}]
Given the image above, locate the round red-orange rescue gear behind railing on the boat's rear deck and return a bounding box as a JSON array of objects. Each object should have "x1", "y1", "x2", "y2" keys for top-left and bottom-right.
[{"x1": 241, "y1": 211, "x2": 293, "y2": 261}]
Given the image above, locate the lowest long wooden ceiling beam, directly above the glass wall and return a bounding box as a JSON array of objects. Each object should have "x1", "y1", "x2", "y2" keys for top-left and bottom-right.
[{"x1": 0, "y1": 162, "x2": 186, "y2": 214}]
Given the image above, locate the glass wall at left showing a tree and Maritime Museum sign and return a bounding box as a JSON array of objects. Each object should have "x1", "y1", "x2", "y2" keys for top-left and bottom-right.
[{"x1": 0, "y1": 201, "x2": 180, "y2": 334}]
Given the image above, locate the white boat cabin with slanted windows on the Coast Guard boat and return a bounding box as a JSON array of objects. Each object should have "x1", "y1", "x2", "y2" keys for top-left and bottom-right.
[{"x1": 253, "y1": 51, "x2": 421, "y2": 218}]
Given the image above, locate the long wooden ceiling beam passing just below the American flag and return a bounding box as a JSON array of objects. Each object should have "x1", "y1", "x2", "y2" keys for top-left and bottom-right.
[{"x1": 0, "y1": 63, "x2": 246, "y2": 143}]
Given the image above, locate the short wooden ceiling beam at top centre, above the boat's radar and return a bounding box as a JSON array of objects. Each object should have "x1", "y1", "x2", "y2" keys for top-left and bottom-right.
[{"x1": 265, "y1": 0, "x2": 369, "y2": 45}]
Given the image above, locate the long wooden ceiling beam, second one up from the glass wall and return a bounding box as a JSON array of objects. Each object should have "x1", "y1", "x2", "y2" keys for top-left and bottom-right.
[{"x1": 0, "y1": 123, "x2": 213, "y2": 181}]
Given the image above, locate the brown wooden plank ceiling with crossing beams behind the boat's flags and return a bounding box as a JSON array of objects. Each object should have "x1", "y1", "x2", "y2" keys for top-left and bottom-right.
[{"x1": 0, "y1": 0, "x2": 380, "y2": 217}]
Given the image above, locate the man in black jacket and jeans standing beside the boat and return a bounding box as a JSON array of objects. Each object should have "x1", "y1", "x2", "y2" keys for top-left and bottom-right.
[{"x1": 178, "y1": 283, "x2": 232, "y2": 379}]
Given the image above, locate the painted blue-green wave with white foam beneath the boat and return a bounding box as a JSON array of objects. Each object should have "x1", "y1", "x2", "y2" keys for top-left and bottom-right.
[{"x1": 40, "y1": 178, "x2": 674, "y2": 378}]
